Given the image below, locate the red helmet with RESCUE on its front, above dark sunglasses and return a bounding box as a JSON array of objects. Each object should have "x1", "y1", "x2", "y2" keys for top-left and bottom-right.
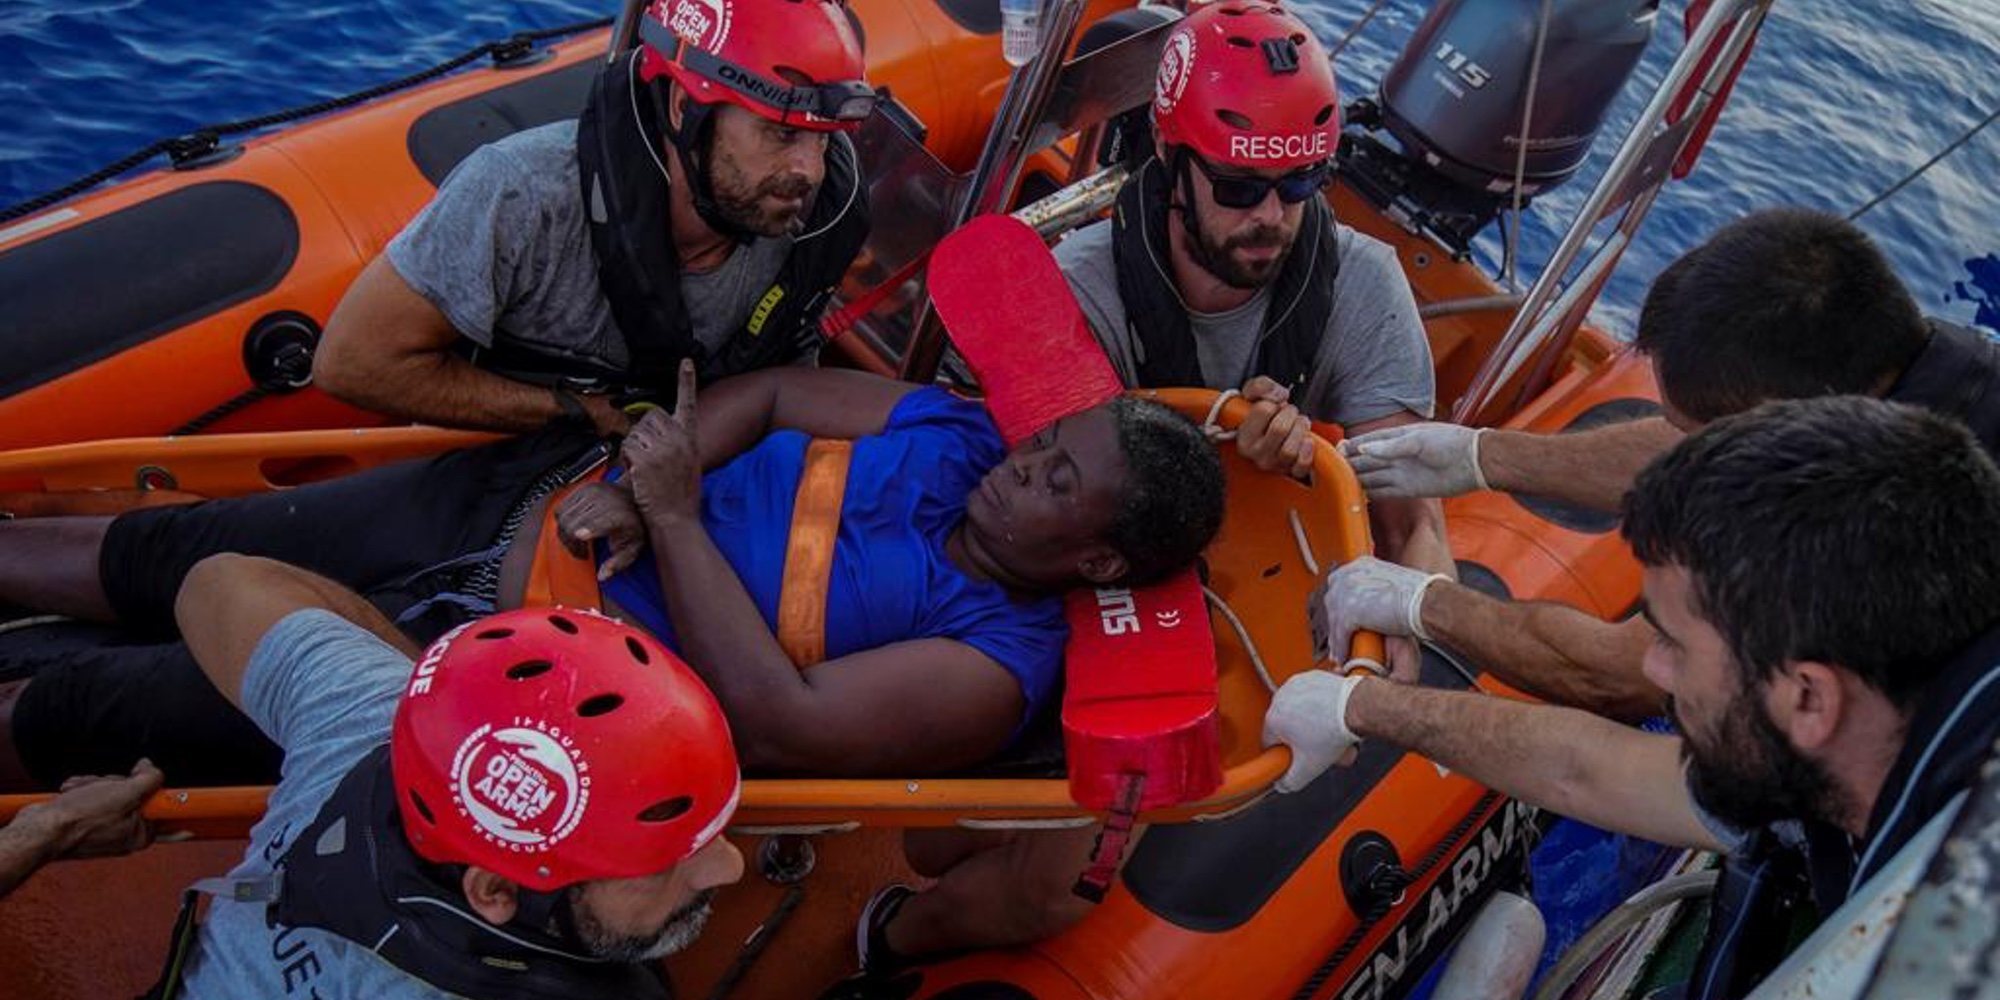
[{"x1": 1152, "y1": 0, "x2": 1340, "y2": 170}]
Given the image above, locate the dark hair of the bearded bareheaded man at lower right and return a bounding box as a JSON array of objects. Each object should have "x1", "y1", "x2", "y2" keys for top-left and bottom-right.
[{"x1": 1624, "y1": 396, "x2": 2000, "y2": 710}]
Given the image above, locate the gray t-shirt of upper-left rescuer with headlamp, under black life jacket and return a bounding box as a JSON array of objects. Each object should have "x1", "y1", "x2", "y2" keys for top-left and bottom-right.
[{"x1": 388, "y1": 120, "x2": 792, "y2": 376}]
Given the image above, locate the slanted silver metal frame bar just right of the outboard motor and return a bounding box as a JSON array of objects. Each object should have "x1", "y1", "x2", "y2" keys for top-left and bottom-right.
[{"x1": 1452, "y1": 0, "x2": 1772, "y2": 422}]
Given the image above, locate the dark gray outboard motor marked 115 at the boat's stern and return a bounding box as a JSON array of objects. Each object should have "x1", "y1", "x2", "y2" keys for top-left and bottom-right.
[{"x1": 1342, "y1": 0, "x2": 1660, "y2": 254}]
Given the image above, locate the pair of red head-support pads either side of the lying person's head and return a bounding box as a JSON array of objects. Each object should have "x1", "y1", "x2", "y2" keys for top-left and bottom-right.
[{"x1": 928, "y1": 216, "x2": 1222, "y2": 810}]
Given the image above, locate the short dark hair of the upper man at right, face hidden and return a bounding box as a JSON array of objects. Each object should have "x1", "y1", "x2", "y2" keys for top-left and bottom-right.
[{"x1": 1634, "y1": 208, "x2": 1930, "y2": 422}]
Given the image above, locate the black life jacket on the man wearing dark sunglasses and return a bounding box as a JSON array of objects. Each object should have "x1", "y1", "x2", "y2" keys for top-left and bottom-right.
[{"x1": 1112, "y1": 158, "x2": 1340, "y2": 398}]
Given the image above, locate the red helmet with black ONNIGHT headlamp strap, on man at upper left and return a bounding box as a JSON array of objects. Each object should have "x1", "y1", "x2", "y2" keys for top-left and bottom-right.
[{"x1": 638, "y1": 0, "x2": 876, "y2": 132}]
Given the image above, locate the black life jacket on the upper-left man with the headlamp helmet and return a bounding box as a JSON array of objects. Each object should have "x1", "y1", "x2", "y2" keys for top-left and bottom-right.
[{"x1": 480, "y1": 52, "x2": 868, "y2": 404}]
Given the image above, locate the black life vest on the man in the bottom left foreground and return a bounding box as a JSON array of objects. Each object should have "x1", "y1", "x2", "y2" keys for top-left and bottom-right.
[{"x1": 270, "y1": 744, "x2": 670, "y2": 1000}]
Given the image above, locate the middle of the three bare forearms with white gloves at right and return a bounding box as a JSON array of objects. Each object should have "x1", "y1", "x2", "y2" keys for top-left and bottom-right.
[{"x1": 1422, "y1": 580, "x2": 1666, "y2": 722}]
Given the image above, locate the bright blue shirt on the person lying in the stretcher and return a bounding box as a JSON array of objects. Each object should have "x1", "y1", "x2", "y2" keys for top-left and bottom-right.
[{"x1": 604, "y1": 388, "x2": 1068, "y2": 722}]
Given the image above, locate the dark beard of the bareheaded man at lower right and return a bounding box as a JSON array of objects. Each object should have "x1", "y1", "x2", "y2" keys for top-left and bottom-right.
[{"x1": 1668, "y1": 688, "x2": 1842, "y2": 830}]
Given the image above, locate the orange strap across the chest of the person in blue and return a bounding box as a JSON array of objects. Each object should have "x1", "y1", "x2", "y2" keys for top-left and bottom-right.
[{"x1": 778, "y1": 438, "x2": 854, "y2": 670}]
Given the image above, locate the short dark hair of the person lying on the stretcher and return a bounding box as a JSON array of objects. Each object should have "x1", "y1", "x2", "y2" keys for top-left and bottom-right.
[{"x1": 1104, "y1": 396, "x2": 1226, "y2": 586}]
